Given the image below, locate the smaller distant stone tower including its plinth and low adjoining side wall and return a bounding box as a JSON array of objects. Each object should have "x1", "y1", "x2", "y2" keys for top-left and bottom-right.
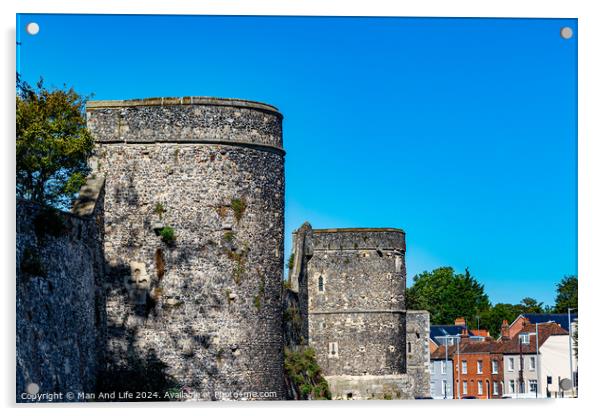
[{"x1": 290, "y1": 223, "x2": 430, "y2": 399}]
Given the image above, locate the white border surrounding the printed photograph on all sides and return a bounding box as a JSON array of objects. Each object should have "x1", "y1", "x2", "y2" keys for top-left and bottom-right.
[{"x1": 0, "y1": 0, "x2": 602, "y2": 415}]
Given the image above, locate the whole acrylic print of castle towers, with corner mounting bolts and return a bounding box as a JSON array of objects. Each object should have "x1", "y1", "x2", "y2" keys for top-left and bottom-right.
[{"x1": 16, "y1": 14, "x2": 578, "y2": 403}]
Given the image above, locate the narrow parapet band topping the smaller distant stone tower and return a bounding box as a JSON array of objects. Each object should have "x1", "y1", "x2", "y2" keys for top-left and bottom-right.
[{"x1": 313, "y1": 228, "x2": 406, "y2": 251}]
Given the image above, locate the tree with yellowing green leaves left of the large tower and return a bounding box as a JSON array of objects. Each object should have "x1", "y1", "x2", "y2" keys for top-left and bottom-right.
[{"x1": 16, "y1": 77, "x2": 94, "y2": 209}]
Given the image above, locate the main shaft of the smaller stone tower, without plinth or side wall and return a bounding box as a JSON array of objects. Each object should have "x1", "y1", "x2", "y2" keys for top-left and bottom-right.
[{"x1": 307, "y1": 229, "x2": 406, "y2": 376}]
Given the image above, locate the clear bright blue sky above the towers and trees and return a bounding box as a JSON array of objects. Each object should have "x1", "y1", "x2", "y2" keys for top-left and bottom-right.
[{"x1": 17, "y1": 15, "x2": 577, "y2": 304}]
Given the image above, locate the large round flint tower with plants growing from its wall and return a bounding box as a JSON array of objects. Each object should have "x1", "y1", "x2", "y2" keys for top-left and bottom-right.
[{"x1": 87, "y1": 97, "x2": 284, "y2": 400}]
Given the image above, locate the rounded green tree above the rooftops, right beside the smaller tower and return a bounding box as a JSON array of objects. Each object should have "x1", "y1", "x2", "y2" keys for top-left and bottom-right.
[{"x1": 406, "y1": 267, "x2": 490, "y2": 327}]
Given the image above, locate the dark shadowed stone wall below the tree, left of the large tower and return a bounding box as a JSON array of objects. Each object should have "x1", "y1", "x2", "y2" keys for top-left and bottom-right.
[{"x1": 16, "y1": 177, "x2": 105, "y2": 402}]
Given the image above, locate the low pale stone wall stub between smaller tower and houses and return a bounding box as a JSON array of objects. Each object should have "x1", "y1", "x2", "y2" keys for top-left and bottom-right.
[{"x1": 406, "y1": 311, "x2": 431, "y2": 397}]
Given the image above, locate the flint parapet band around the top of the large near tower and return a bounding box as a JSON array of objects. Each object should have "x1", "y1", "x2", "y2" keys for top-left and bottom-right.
[{"x1": 86, "y1": 97, "x2": 283, "y2": 153}]
